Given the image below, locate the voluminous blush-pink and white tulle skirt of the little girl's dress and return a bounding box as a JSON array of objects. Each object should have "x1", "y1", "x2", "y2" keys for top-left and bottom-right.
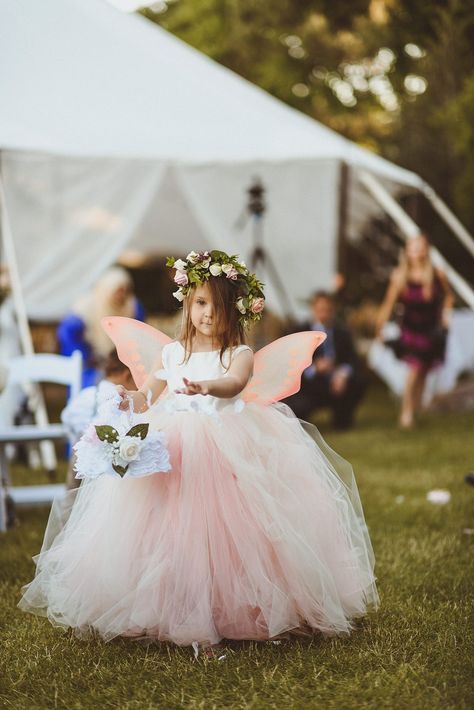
[{"x1": 19, "y1": 404, "x2": 378, "y2": 645}]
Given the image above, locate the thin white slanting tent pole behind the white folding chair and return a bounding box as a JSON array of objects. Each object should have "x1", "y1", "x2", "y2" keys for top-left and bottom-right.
[{"x1": 0, "y1": 156, "x2": 57, "y2": 471}]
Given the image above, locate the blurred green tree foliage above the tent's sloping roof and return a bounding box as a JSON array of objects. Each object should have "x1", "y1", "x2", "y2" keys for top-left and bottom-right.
[{"x1": 144, "y1": 0, "x2": 474, "y2": 262}]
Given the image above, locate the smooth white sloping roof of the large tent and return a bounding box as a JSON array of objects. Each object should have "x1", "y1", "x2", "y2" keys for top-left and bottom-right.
[{"x1": 0, "y1": 0, "x2": 421, "y2": 186}]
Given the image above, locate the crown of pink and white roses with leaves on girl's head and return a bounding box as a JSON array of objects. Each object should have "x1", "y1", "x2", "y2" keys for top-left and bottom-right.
[{"x1": 166, "y1": 250, "x2": 265, "y2": 326}]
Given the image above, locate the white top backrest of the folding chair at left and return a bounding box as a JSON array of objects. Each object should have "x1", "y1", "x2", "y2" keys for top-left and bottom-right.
[{"x1": 7, "y1": 350, "x2": 82, "y2": 398}]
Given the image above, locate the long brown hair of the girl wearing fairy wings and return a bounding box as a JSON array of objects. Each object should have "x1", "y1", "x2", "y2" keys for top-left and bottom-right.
[{"x1": 179, "y1": 276, "x2": 245, "y2": 364}]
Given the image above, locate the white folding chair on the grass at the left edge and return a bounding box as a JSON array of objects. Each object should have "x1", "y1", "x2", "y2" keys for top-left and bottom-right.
[{"x1": 0, "y1": 350, "x2": 82, "y2": 532}]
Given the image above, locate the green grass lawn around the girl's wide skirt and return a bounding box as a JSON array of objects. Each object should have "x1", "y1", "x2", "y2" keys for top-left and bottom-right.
[{"x1": 0, "y1": 389, "x2": 474, "y2": 710}]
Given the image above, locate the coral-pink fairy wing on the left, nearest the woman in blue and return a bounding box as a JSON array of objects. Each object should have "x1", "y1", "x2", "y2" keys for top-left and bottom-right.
[{"x1": 101, "y1": 316, "x2": 172, "y2": 387}]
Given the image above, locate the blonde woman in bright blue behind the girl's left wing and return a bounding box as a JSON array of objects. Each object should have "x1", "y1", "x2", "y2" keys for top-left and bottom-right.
[{"x1": 58, "y1": 266, "x2": 145, "y2": 387}]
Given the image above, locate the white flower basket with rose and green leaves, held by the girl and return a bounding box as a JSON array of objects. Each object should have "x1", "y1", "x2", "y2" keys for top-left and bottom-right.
[{"x1": 74, "y1": 417, "x2": 171, "y2": 478}]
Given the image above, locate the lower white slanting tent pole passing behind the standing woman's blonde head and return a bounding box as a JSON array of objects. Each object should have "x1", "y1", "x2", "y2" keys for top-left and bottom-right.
[{"x1": 357, "y1": 170, "x2": 474, "y2": 309}]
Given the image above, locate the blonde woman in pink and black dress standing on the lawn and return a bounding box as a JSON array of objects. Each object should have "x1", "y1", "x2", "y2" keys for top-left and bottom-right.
[{"x1": 377, "y1": 234, "x2": 453, "y2": 429}]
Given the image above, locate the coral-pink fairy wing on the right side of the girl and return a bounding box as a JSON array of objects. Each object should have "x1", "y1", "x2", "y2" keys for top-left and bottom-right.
[{"x1": 241, "y1": 330, "x2": 326, "y2": 404}]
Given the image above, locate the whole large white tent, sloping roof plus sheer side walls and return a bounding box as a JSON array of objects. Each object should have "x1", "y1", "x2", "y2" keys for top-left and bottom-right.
[{"x1": 0, "y1": 0, "x2": 422, "y2": 319}]
